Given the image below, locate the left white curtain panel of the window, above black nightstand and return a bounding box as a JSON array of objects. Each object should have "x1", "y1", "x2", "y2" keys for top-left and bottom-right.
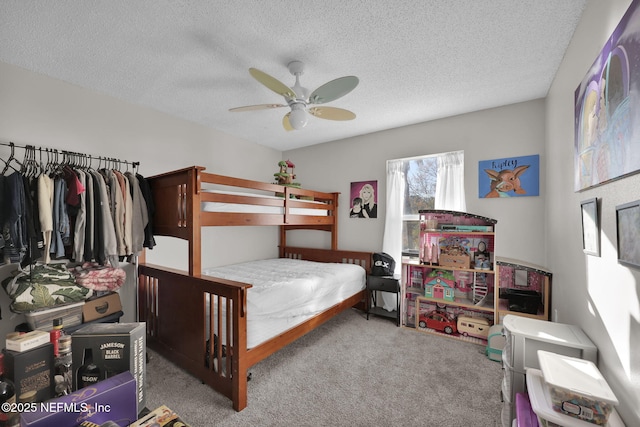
[{"x1": 381, "y1": 160, "x2": 406, "y2": 311}]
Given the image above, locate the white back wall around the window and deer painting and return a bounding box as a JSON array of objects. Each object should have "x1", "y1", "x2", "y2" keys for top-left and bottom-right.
[{"x1": 283, "y1": 100, "x2": 546, "y2": 265}]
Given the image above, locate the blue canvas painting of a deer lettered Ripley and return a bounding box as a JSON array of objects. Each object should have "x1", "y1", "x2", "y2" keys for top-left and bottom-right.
[{"x1": 478, "y1": 154, "x2": 540, "y2": 199}]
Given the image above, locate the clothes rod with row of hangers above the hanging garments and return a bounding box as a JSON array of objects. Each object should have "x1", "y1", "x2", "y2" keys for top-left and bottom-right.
[{"x1": 0, "y1": 141, "x2": 140, "y2": 173}]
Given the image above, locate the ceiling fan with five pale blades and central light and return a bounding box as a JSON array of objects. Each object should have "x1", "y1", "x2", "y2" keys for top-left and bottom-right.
[{"x1": 229, "y1": 61, "x2": 359, "y2": 131}]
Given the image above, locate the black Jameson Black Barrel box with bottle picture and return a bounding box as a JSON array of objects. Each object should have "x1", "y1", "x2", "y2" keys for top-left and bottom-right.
[{"x1": 71, "y1": 323, "x2": 146, "y2": 408}]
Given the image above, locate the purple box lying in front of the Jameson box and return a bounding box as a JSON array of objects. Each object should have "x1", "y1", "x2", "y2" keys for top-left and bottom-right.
[{"x1": 21, "y1": 371, "x2": 138, "y2": 427}]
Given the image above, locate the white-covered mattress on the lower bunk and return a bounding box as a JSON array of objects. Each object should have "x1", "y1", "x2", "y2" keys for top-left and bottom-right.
[{"x1": 202, "y1": 258, "x2": 366, "y2": 348}]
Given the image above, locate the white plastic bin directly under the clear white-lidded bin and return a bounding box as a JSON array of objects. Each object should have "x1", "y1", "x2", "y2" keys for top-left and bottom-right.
[{"x1": 527, "y1": 368, "x2": 624, "y2": 427}]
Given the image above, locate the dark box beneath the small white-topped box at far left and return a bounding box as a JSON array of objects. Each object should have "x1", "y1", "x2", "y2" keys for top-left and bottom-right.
[{"x1": 3, "y1": 343, "x2": 55, "y2": 402}]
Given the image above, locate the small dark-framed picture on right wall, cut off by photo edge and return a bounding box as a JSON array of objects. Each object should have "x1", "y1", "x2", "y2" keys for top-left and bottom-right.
[{"x1": 616, "y1": 200, "x2": 640, "y2": 268}]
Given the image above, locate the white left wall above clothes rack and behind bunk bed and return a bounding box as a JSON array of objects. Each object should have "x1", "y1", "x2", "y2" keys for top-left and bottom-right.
[{"x1": 0, "y1": 63, "x2": 281, "y2": 337}]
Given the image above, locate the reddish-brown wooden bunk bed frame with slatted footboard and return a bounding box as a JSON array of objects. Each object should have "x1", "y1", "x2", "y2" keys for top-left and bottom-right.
[{"x1": 138, "y1": 166, "x2": 372, "y2": 411}]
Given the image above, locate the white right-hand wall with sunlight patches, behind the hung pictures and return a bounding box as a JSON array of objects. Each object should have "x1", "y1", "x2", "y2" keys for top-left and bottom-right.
[{"x1": 546, "y1": 0, "x2": 640, "y2": 426}]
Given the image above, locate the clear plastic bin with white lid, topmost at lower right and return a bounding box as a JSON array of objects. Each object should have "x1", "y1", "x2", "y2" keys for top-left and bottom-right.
[{"x1": 538, "y1": 350, "x2": 618, "y2": 425}]
